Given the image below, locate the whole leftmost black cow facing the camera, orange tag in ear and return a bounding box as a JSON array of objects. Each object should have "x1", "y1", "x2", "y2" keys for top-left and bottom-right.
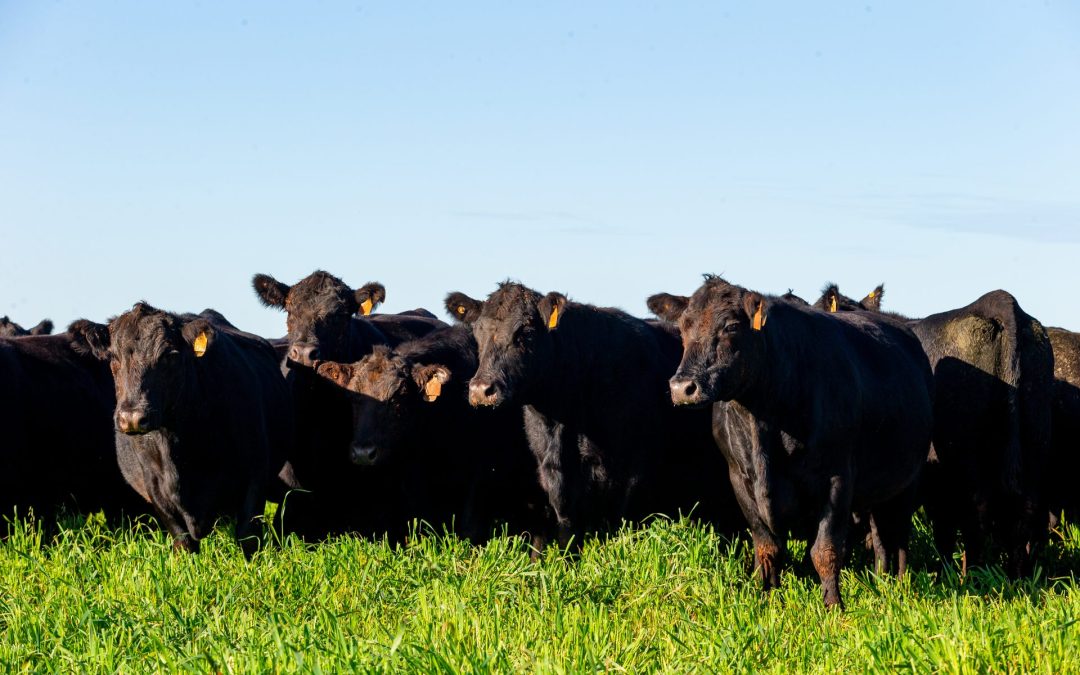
[{"x1": 70, "y1": 302, "x2": 293, "y2": 558}]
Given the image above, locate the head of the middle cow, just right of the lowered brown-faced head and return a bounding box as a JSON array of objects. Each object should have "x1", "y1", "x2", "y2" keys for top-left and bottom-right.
[{"x1": 446, "y1": 282, "x2": 568, "y2": 406}]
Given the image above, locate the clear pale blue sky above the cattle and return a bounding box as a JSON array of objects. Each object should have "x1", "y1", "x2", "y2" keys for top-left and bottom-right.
[{"x1": 0, "y1": 0, "x2": 1080, "y2": 335}]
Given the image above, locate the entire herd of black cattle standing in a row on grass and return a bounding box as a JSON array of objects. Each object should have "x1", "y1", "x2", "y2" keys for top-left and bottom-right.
[{"x1": 0, "y1": 271, "x2": 1080, "y2": 605}]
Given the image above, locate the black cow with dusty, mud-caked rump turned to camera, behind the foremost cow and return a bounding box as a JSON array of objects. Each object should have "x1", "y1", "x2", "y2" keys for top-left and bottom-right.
[{"x1": 816, "y1": 285, "x2": 1054, "y2": 577}]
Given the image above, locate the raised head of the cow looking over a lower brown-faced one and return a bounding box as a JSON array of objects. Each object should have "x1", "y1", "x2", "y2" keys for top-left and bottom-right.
[{"x1": 252, "y1": 270, "x2": 387, "y2": 367}]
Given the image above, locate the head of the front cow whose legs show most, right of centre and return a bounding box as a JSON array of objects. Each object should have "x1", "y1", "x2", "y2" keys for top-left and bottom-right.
[{"x1": 648, "y1": 274, "x2": 775, "y2": 405}]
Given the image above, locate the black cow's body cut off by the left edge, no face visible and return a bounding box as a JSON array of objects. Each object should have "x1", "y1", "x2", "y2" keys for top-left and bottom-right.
[{"x1": 0, "y1": 324, "x2": 146, "y2": 526}]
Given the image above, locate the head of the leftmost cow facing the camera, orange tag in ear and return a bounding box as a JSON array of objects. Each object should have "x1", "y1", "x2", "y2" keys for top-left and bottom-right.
[{"x1": 68, "y1": 302, "x2": 217, "y2": 435}]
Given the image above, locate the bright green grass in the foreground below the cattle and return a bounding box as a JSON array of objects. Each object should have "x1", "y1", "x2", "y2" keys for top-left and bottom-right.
[{"x1": 0, "y1": 517, "x2": 1080, "y2": 673}]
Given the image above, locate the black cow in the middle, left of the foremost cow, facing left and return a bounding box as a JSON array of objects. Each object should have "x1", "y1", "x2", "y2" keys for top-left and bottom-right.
[{"x1": 446, "y1": 282, "x2": 738, "y2": 545}]
